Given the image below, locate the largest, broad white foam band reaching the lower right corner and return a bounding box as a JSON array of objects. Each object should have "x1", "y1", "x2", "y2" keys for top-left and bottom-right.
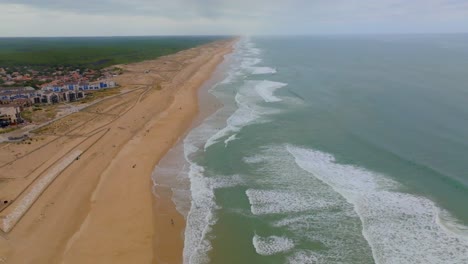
[{"x1": 287, "y1": 146, "x2": 468, "y2": 264}]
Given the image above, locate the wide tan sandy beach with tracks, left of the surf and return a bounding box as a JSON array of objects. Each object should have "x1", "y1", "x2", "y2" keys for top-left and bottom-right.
[{"x1": 0, "y1": 40, "x2": 234, "y2": 263}]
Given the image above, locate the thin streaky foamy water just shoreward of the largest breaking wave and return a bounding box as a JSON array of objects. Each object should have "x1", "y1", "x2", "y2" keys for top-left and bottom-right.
[{"x1": 244, "y1": 146, "x2": 372, "y2": 263}]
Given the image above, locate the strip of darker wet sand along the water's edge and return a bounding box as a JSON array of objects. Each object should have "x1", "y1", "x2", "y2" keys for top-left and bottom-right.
[{"x1": 153, "y1": 54, "x2": 232, "y2": 263}]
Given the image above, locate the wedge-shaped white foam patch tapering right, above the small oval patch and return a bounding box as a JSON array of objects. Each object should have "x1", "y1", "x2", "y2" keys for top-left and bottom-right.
[{"x1": 246, "y1": 189, "x2": 333, "y2": 215}]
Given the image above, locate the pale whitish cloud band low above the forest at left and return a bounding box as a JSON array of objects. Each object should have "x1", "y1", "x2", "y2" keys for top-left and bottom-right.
[{"x1": 0, "y1": 4, "x2": 266, "y2": 37}]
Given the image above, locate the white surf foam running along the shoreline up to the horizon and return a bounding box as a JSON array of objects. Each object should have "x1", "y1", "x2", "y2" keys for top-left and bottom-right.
[{"x1": 183, "y1": 40, "x2": 286, "y2": 263}]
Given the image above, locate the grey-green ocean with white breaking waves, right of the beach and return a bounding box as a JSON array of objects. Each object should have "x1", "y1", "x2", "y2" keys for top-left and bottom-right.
[{"x1": 156, "y1": 34, "x2": 468, "y2": 264}]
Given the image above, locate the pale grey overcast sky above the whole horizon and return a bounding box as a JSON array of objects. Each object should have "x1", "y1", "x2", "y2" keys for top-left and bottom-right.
[{"x1": 0, "y1": 0, "x2": 468, "y2": 37}]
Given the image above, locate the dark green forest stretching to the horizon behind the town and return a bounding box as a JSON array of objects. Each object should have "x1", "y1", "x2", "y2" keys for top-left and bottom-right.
[{"x1": 0, "y1": 36, "x2": 227, "y2": 69}]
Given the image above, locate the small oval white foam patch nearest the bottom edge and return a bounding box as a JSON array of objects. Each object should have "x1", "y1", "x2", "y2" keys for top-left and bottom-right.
[{"x1": 252, "y1": 235, "x2": 294, "y2": 256}]
